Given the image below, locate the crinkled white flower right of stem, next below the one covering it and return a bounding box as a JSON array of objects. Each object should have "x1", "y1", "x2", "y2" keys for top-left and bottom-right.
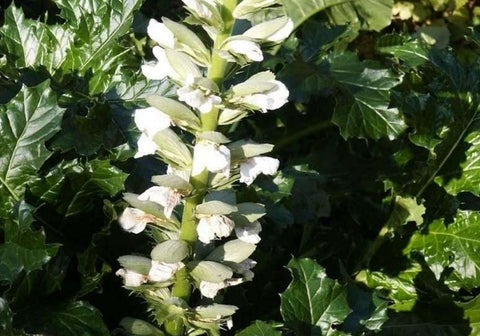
[{"x1": 197, "y1": 215, "x2": 235, "y2": 244}]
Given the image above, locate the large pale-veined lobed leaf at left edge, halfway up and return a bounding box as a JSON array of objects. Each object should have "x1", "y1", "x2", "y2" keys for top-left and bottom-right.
[{"x1": 0, "y1": 81, "x2": 64, "y2": 213}]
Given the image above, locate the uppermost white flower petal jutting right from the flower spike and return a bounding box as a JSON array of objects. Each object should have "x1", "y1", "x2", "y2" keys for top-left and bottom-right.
[{"x1": 243, "y1": 17, "x2": 294, "y2": 42}]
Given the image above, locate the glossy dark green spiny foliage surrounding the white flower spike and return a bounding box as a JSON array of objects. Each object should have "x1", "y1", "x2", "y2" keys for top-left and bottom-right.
[{"x1": 0, "y1": 0, "x2": 480, "y2": 336}]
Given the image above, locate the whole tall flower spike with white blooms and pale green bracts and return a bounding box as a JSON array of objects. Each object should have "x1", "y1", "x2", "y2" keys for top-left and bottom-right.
[{"x1": 117, "y1": 0, "x2": 294, "y2": 335}]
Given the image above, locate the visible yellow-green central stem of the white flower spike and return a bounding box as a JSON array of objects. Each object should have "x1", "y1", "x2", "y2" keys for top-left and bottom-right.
[{"x1": 165, "y1": 0, "x2": 237, "y2": 336}]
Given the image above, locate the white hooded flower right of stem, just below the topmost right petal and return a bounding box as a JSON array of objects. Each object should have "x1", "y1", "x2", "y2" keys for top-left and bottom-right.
[{"x1": 220, "y1": 36, "x2": 263, "y2": 62}]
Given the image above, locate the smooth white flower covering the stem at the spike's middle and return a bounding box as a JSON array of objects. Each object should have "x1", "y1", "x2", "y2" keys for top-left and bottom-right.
[{"x1": 192, "y1": 142, "x2": 230, "y2": 177}]
